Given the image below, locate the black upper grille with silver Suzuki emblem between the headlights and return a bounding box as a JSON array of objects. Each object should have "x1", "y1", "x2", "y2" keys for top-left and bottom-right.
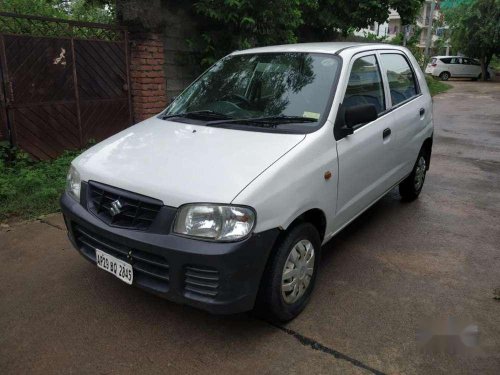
[{"x1": 88, "y1": 182, "x2": 163, "y2": 230}]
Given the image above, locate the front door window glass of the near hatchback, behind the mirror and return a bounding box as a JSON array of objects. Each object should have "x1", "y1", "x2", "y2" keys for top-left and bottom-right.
[{"x1": 343, "y1": 55, "x2": 385, "y2": 113}]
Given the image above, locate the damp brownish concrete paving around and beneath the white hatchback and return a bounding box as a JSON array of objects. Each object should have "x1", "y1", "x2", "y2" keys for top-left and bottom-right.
[{"x1": 0, "y1": 82, "x2": 500, "y2": 374}]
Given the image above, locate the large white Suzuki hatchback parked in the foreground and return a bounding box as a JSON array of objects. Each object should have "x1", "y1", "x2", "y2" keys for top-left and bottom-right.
[{"x1": 61, "y1": 43, "x2": 433, "y2": 321}]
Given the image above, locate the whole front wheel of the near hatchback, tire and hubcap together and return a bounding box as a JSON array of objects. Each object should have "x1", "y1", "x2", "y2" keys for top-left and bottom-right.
[{"x1": 255, "y1": 223, "x2": 321, "y2": 323}]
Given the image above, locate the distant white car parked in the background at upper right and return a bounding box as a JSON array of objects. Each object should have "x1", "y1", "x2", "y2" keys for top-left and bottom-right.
[{"x1": 425, "y1": 56, "x2": 494, "y2": 81}]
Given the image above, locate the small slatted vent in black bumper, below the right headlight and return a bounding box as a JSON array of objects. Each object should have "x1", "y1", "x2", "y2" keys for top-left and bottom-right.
[{"x1": 184, "y1": 266, "x2": 219, "y2": 298}]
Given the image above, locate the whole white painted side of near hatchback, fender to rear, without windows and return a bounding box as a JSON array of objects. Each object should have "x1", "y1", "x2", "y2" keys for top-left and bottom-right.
[{"x1": 231, "y1": 45, "x2": 432, "y2": 243}]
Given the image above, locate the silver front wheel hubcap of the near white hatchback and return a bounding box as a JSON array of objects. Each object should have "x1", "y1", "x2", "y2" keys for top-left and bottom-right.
[{"x1": 281, "y1": 240, "x2": 314, "y2": 304}]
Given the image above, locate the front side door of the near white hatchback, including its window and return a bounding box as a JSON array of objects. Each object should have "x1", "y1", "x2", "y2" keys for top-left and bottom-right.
[{"x1": 335, "y1": 52, "x2": 392, "y2": 227}]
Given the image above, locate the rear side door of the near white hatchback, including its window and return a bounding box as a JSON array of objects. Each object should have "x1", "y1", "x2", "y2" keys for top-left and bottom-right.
[{"x1": 380, "y1": 51, "x2": 432, "y2": 184}]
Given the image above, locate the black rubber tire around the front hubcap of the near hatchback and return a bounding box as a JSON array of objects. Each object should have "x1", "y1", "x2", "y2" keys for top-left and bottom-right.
[{"x1": 261, "y1": 223, "x2": 321, "y2": 322}]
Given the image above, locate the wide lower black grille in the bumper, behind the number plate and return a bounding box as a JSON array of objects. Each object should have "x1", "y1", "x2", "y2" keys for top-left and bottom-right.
[{"x1": 73, "y1": 225, "x2": 169, "y2": 293}]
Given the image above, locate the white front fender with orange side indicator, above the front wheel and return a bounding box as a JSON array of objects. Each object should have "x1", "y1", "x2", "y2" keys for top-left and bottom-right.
[{"x1": 231, "y1": 121, "x2": 338, "y2": 241}]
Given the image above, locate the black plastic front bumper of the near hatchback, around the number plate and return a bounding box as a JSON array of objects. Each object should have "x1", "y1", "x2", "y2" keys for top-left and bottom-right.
[{"x1": 60, "y1": 193, "x2": 279, "y2": 314}]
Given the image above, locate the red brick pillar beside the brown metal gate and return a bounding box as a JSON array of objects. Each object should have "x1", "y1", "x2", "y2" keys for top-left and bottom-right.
[{"x1": 130, "y1": 33, "x2": 167, "y2": 123}]
